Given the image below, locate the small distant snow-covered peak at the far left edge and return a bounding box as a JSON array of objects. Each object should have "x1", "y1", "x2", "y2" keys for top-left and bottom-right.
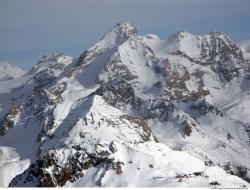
[{"x1": 0, "y1": 62, "x2": 25, "y2": 81}]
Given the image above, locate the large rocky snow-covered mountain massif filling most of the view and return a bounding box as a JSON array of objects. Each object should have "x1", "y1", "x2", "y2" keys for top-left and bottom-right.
[{"x1": 0, "y1": 22, "x2": 250, "y2": 187}]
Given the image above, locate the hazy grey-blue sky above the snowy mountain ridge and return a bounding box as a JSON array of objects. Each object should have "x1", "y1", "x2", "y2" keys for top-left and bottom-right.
[{"x1": 0, "y1": 0, "x2": 250, "y2": 70}]
